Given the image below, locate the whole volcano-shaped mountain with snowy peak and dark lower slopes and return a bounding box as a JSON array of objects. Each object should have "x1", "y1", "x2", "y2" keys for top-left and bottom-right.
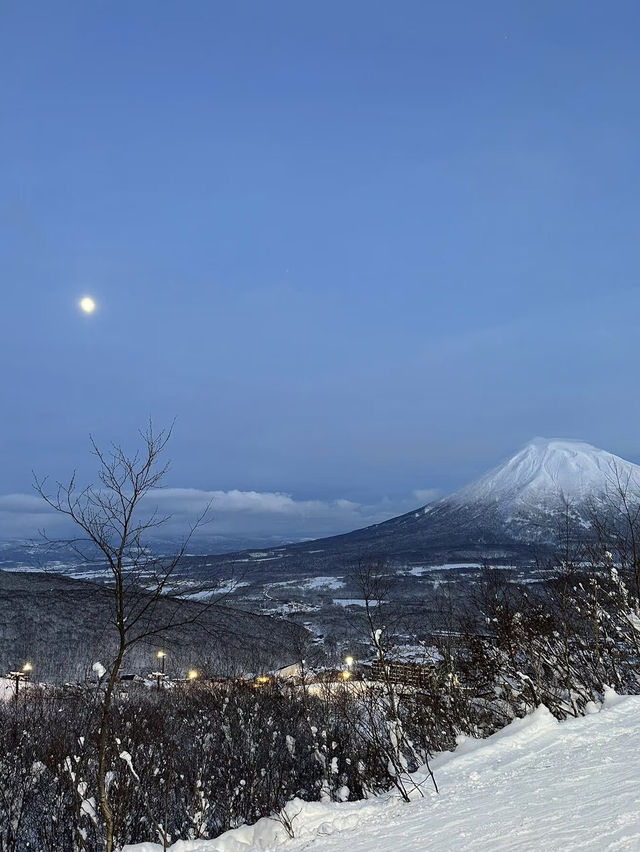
[{"x1": 198, "y1": 438, "x2": 640, "y2": 573}]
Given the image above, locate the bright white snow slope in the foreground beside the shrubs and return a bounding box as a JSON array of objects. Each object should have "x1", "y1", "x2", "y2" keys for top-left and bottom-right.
[{"x1": 123, "y1": 693, "x2": 640, "y2": 852}]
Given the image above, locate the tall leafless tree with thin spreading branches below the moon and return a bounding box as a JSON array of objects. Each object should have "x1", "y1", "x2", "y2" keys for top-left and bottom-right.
[{"x1": 34, "y1": 423, "x2": 212, "y2": 852}]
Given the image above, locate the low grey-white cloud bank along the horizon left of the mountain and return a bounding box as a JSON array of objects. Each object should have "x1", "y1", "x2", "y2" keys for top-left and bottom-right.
[{"x1": 0, "y1": 488, "x2": 437, "y2": 547}]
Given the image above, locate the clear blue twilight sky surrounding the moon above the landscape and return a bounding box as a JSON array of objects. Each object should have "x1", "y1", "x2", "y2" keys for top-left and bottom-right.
[{"x1": 0, "y1": 0, "x2": 640, "y2": 538}]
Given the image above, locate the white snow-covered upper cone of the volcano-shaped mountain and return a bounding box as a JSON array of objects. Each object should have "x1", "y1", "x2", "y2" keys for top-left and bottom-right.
[{"x1": 446, "y1": 438, "x2": 640, "y2": 514}]
